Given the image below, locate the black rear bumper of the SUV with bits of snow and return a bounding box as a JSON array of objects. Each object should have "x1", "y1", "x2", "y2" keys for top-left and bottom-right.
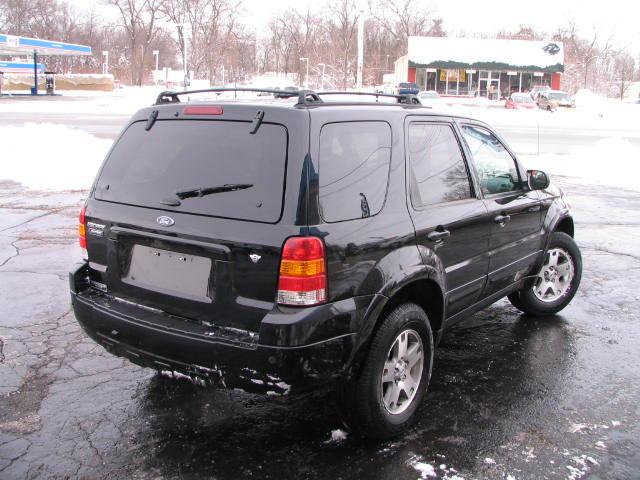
[{"x1": 70, "y1": 265, "x2": 373, "y2": 395}]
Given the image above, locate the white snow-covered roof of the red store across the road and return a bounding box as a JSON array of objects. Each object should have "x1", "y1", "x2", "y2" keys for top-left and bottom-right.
[{"x1": 408, "y1": 37, "x2": 564, "y2": 73}]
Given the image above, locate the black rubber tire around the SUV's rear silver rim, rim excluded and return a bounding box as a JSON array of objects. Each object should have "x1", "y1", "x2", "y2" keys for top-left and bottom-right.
[{"x1": 339, "y1": 303, "x2": 434, "y2": 440}]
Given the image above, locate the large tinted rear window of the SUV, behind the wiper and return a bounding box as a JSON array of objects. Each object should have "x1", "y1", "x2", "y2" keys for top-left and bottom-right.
[{"x1": 95, "y1": 120, "x2": 288, "y2": 223}]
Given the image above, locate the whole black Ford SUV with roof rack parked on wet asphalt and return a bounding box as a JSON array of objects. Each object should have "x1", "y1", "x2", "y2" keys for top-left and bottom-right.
[{"x1": 70, "y1": 90, "x2": 582, "y2": 438}]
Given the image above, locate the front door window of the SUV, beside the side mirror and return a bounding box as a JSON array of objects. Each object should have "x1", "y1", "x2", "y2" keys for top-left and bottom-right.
[{"x1": 462, "y1": 125, "x2": 521, "y2": 195}]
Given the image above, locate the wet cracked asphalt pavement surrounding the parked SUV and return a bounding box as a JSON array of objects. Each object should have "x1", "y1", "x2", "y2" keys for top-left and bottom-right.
[{"x1": 0, "y1": 178, "x2": 640, "y2": 480}]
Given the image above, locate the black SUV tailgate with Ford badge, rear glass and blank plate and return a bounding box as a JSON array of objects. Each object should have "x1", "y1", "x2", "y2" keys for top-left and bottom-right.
[{"x1": 86, "y1": 105, "x2": 308, "y2": 331}]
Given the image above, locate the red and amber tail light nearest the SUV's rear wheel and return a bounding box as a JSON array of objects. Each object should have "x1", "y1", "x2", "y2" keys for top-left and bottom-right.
[{"x1": 278, "y1": 237, "x2": 327, "y2": 306}]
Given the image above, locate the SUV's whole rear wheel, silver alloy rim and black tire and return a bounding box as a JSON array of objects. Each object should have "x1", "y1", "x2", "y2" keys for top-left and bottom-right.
[{"x1": 340, "y1": 303, "x2": 433, "y2": 439}]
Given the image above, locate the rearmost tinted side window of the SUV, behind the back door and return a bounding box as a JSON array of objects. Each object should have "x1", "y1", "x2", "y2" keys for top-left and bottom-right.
[{"x1": 319, "y1": 122, "x2": 391, "y2": 222}]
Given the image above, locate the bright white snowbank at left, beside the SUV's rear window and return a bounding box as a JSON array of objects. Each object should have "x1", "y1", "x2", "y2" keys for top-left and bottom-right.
[{"x1": 0, "y1": 123, "x2": 112, "y2": 190}]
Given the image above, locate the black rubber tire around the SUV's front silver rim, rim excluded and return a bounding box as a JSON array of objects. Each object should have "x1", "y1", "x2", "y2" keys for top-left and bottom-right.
[{"x1": 508, "y1": 232, "x2": 582, "y2": 316}]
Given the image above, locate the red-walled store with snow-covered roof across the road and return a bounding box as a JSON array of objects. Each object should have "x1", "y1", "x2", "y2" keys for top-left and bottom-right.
[{"x1": 395, "y1": 37, "x2": 564, "y2": 98}]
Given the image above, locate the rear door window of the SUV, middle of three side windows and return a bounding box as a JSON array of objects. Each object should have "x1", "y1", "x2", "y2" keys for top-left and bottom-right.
[{"x1": 409, "y1": 123, "x2": 471, "y2": 208}]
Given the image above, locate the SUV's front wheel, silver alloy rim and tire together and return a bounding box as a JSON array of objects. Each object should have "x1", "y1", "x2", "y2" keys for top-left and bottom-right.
[{"x1": 509, "y1": 232, "x2": 582, "y2": 316}]
